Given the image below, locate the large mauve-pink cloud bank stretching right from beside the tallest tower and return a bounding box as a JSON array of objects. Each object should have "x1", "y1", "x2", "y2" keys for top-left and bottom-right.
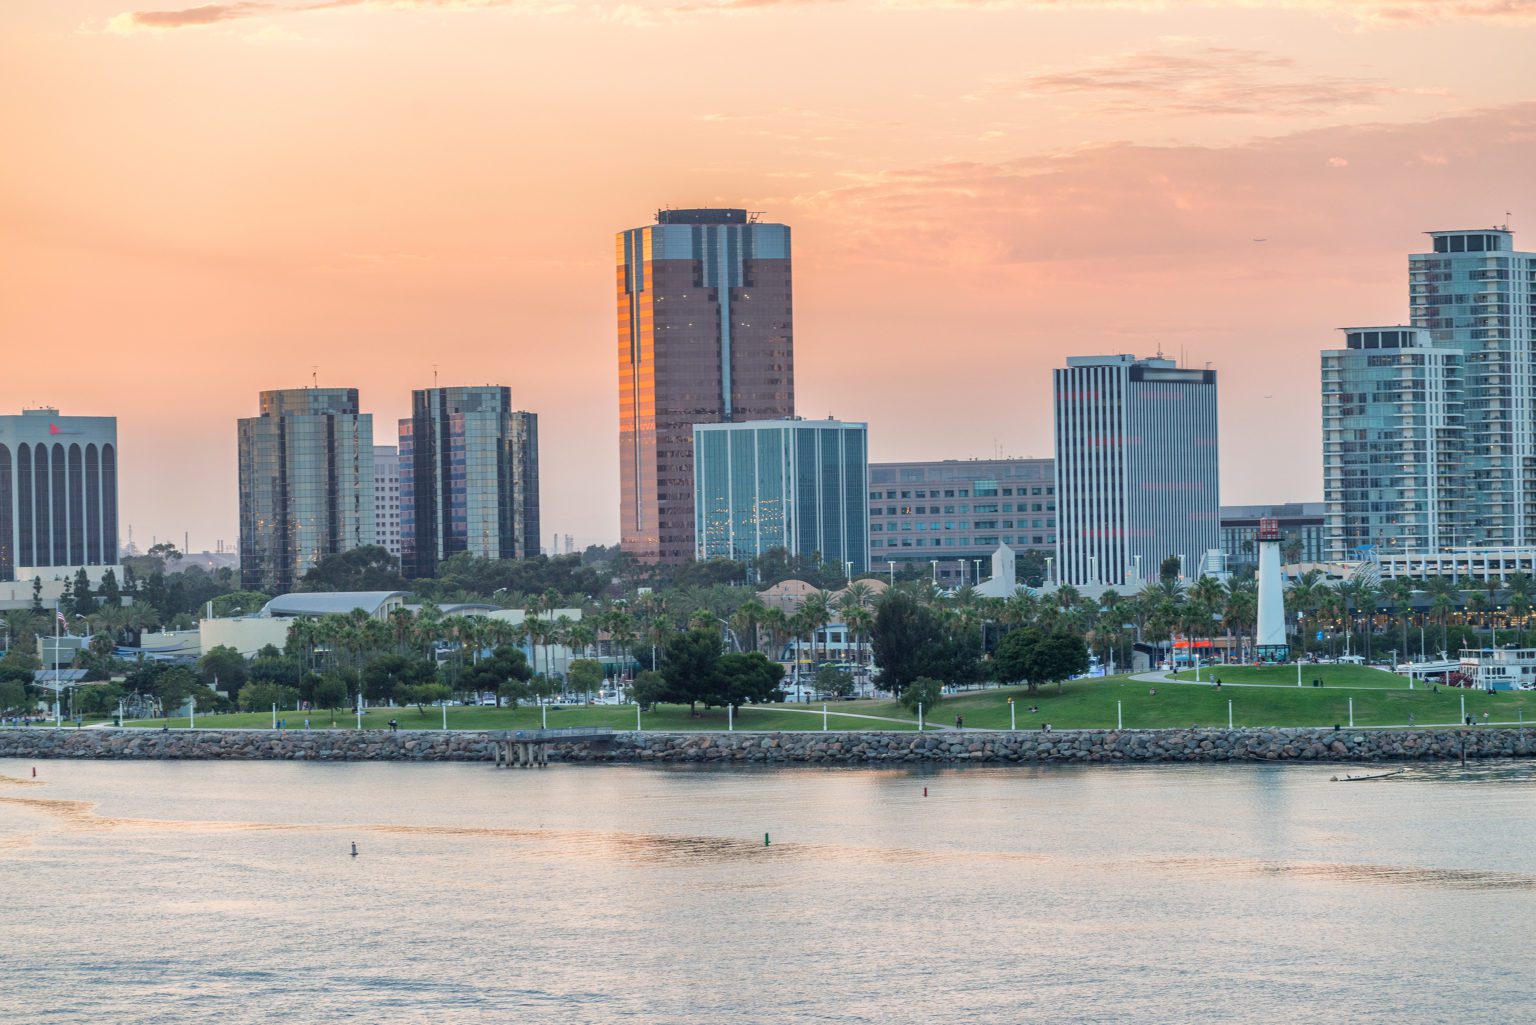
[{"x1": 780, "y1": 103, "x2": 1536, "y2": 270}]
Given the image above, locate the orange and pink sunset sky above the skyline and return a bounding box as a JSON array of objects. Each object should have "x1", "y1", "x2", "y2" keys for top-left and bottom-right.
[{"x1": 0, "y1": 0, "x2": 1536, "y2": 550}]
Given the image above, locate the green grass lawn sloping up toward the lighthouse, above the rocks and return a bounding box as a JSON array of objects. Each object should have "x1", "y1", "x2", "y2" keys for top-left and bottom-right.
[{"x1": 111, "y1": 676, "x2": 1536, "y2": 730}]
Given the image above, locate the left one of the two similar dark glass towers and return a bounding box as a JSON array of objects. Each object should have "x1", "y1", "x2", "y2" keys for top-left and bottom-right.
[{"x1": 238, "y1": 387, "x2": 375, "y2": 595}]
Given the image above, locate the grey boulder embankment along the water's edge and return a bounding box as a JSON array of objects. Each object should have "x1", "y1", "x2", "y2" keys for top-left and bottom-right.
[{"x1": 0, "y1": 727, "x2": 1536, "y2": 765}]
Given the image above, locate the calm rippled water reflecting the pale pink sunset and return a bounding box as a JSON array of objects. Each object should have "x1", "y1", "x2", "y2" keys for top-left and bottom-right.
[{"x1": 0, "y1": 761, "x2": 1536, "y2": 1025}]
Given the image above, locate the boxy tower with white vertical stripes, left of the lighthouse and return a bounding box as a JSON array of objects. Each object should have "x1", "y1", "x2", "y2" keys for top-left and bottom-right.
[{"x1": 1054, "y1": 355, "x2": 1221, "y2": 590}]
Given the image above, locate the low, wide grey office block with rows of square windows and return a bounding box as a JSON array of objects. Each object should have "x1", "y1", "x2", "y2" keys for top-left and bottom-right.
[{"x1": 869, "y1": 459, "x2": 1057, "y2": 585}]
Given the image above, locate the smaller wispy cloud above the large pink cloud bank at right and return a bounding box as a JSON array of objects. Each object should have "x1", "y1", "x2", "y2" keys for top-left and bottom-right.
[{"x1": 986, "y1": 46, "x2": 1401, "y2": 117}]
